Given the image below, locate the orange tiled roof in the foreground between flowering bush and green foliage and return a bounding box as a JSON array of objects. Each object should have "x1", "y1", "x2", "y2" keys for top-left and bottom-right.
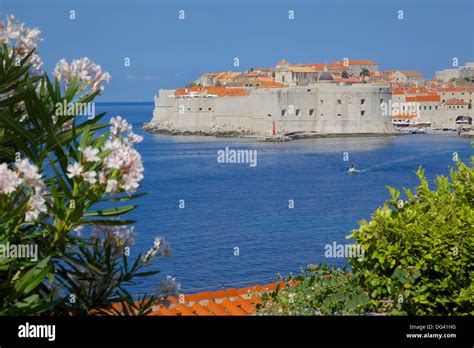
[{"x1": 150, "y1": 282, "x2": 283, "y2": 316}]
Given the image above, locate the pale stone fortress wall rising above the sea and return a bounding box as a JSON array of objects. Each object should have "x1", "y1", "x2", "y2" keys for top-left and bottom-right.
[{"x1": 151, "y1": 82, "x2": 395, "y2": 135}]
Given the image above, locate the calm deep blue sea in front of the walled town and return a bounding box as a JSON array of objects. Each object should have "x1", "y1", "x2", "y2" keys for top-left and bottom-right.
[{"x1": 97, "y1": 104, "x2": 472, "y2": 292}]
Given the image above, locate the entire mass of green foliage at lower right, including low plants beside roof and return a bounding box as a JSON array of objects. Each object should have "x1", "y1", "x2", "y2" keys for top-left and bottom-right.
[{"x1": 258, "y1": 151, "x2": 474, "y2": 315}]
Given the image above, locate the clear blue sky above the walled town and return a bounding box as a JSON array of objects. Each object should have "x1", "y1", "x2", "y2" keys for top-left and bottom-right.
[{"x1": 0, "y1": 0, "x2": 474, "y2": 102}]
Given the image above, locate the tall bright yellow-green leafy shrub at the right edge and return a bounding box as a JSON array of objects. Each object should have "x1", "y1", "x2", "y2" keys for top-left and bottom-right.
[{"x1": 349, "y1": 163, "x2": 474, "y2": 315}]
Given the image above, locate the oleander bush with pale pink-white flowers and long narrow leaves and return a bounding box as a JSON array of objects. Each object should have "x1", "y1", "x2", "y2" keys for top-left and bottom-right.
[{"x1": 0, "y1": 16, "x2": 179, "y2": 315}]
